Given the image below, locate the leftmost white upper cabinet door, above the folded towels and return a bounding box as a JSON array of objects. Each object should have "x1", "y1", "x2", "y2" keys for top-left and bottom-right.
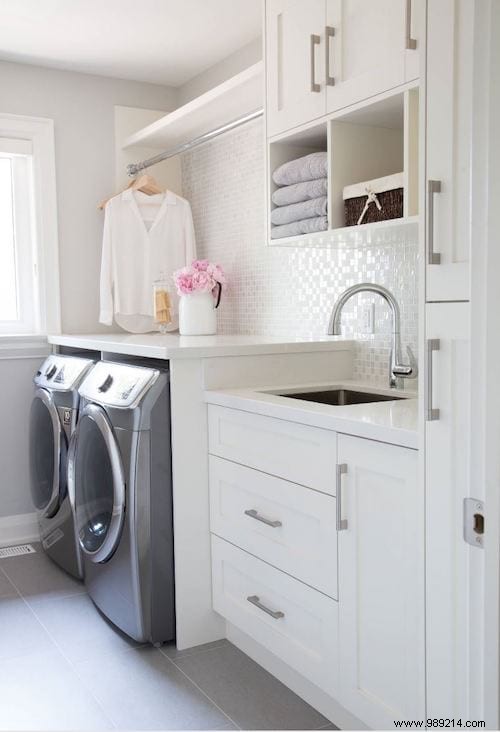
[{"x1": 266, "y1": 0, "x2": 326, "y2": 137}]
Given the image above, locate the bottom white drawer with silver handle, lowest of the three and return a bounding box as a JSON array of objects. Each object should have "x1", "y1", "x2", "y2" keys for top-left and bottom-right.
[{"x1": 212, "y1": 536, "x2": 338, "y2": 694}]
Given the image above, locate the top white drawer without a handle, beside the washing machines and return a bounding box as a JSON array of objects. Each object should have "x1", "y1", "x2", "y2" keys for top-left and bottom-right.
[{"x1": 208, "y1": 405, "x2": 337, "y2": 495}]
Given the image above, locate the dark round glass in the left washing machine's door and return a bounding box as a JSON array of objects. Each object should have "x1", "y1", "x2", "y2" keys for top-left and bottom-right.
[{"x1": 29, "y1": 396, "x2": 64, "y2": 512}]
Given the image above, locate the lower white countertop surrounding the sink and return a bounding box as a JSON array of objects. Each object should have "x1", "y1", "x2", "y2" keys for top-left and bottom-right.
[{"x1": 205, "y1": 381, "x2": 418, "y2": 450}]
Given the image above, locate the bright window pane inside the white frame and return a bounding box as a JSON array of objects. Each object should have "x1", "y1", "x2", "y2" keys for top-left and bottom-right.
[{"x1": 0, "y1": 138, "x2": 40, "y2": 334}]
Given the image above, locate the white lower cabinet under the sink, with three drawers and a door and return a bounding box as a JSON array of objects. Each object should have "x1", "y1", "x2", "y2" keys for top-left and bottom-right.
[{"x1": 209, "y1": 407, "x2": 425, "y2": 729}]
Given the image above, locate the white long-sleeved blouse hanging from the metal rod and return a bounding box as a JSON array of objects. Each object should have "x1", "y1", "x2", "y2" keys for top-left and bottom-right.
[{"x1": 99, "y1": 190, "x2": 196, "y2": 333}]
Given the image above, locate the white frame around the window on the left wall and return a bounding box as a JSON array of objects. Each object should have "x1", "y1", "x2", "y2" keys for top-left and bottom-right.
[{"x1": 0, "y1": 113, "x2": 61, "y2": 344}]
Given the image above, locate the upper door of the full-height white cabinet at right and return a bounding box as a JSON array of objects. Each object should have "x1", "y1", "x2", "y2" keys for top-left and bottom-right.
[{"x1": 426, "y1": 0, "x2": 474, "y2": 302}]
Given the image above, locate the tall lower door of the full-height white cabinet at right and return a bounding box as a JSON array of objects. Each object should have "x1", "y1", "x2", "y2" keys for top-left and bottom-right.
[{"x1": 425, "y1": 303, "x2": 484, "y2": 726}]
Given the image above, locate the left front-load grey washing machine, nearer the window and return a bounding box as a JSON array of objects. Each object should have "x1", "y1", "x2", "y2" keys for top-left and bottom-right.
[{"x1": 29, "y1": 355, "x2": 94, "y2": 579}]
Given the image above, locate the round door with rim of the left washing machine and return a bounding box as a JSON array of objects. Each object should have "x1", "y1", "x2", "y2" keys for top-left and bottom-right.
[{"x1": 29, "y1": 389, "x2": 67, "y2": 518}]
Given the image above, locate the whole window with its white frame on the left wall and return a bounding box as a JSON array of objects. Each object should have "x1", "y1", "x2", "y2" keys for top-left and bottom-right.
[{"x1": 0, "y1": 114, "x2": 60, "y2": 337}]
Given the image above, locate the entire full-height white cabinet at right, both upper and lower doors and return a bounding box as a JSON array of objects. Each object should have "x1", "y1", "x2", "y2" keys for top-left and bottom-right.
[{"x1": 421, "y1": 0, "x2": 484, "y2": 726}]
